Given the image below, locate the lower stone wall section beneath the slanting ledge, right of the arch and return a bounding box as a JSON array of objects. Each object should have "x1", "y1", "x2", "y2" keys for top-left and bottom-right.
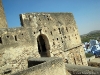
[{"x1": 64, "y1": 45, "x2": 87, "y2": 65}]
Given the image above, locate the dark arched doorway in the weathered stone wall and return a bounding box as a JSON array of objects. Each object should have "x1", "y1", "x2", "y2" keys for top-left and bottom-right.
[{"x1": 37, "y1": 34, "x2": 50, "y2": 57}]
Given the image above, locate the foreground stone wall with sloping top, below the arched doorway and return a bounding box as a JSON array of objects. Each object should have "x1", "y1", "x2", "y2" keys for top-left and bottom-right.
[{"x1": 12, "y1": 58, "x2": 70, "y2": 75}]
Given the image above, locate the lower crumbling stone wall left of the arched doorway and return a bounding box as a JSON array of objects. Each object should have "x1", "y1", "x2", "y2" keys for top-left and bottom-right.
[{"x1": 0, "y1": 28, "x2": 40, "y2": 74}]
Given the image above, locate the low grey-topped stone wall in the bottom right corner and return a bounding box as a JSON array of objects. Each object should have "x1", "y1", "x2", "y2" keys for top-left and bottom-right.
[{"x1": 65, "y1": 64, "x2": 100, "y2": 75}]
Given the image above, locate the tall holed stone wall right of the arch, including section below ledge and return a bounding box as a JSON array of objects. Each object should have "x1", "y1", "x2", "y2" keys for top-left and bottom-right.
[{"x1": 20, "y1": 13, "x2": 87, "y2": 65}]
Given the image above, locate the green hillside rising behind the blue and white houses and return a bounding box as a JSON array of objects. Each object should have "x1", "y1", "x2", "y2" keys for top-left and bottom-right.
[{"x1": 81, "y1": 30, "x2": 100, "y2": 43}]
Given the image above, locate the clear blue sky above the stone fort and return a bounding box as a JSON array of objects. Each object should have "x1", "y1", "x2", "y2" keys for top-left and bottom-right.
[{"x1": 2, "y1": 0, "x2": 100, "y2": 35}]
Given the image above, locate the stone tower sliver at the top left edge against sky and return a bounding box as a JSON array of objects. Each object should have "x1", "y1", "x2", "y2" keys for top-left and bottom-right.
[{"x1": 0, "y1": 0, "x2": 7, "y2": 28}]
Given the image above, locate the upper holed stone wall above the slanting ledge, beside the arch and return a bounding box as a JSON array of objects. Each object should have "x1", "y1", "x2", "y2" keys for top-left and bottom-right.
[{"x1": 21, "y1": 13, "x2": 81, "y2": 50}]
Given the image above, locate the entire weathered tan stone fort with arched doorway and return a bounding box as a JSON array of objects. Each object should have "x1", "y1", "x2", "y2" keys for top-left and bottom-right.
[{"x1": 0, "y1": 0, "x2": 100, "y2": 75}]
